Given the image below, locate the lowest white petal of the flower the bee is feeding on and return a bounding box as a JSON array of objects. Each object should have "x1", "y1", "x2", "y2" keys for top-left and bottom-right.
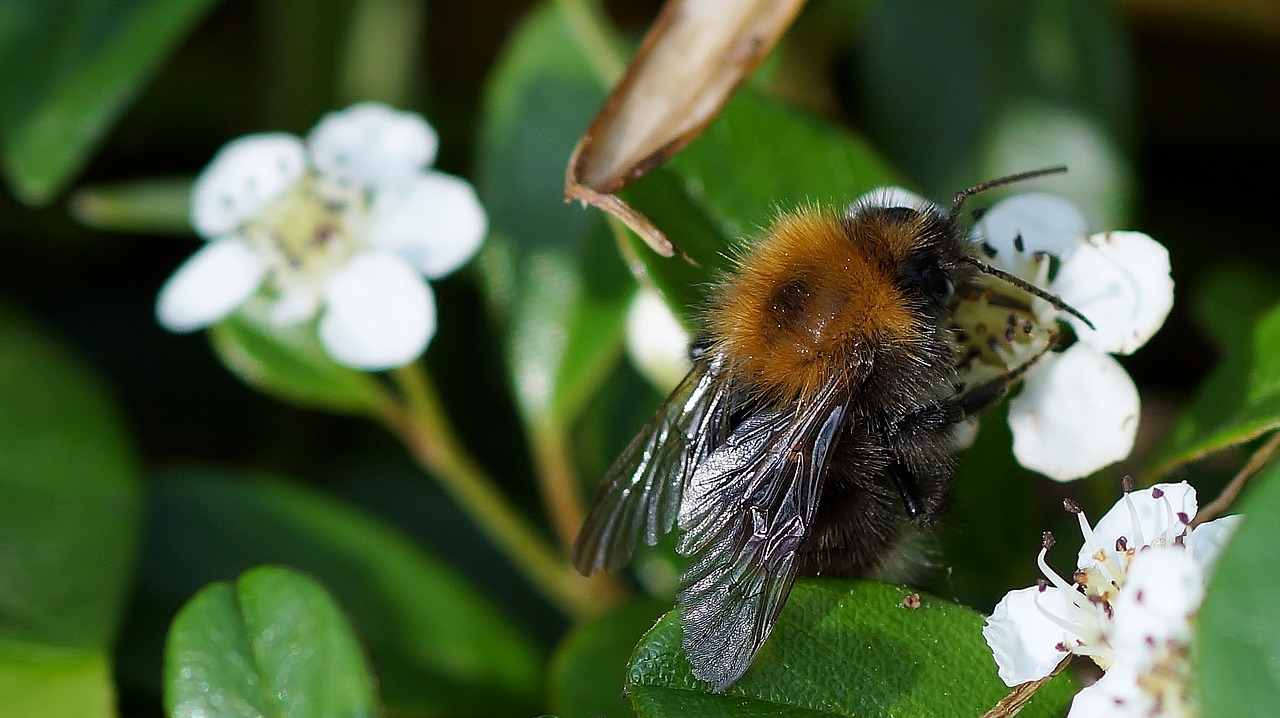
[{"x1": 1009, "y1": 342, "x2": 1140, "y2": 481}]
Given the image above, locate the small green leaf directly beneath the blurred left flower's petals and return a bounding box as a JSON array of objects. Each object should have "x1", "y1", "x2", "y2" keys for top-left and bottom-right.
[{"x1": 209, "y1": 303, "x2": 381, "y2": 413}]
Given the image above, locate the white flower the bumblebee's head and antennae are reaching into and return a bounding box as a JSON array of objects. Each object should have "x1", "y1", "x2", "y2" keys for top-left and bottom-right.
[{"x1": 957, "y1": 193, "x2": 1174, "y2": 481}]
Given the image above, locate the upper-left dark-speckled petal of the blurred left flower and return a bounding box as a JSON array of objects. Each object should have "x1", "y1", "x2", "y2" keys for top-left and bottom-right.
[{"x1": 191, "y1": 132, "x2": 306, "y2": 238}]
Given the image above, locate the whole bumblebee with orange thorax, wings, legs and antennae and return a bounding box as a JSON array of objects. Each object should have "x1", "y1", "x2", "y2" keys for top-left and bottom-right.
[{"x1": 572, "y1": 168, "x2": 1087, "y2": 691}]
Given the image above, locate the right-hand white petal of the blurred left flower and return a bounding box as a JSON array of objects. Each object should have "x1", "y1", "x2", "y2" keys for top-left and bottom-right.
[{"x1": 369, "y1": 172, "x2": 489, "y2": 279}]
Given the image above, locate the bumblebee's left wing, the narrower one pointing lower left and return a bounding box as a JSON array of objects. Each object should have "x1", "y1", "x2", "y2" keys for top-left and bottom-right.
[{"x1": 572, "y1": 357, "x2": 730, "y2": 575}]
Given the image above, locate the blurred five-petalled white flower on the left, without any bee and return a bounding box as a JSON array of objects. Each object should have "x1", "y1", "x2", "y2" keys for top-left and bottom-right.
[{"x1": 156, "y1": 102, "x2": 488, "y2": 370}]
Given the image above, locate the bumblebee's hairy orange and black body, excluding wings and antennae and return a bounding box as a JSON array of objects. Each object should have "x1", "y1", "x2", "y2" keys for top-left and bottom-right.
[{"x1": 704, "y1": 209, "x2": 968, "y2": 576}]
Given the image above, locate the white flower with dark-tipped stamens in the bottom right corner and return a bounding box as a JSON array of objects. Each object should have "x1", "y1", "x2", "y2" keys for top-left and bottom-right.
[{"x1": 983, "y1": 483, "x2": 1239, "y2": 717}]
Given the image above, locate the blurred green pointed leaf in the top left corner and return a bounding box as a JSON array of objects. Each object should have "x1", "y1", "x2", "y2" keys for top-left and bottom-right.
[{"x1": 0, "y1": 0, "x2": 215, "y2": 205}]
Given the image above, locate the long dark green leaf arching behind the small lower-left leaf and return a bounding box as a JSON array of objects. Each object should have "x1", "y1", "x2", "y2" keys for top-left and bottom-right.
[{"x1": 137, "y1": 470, "x2": 540, "y2": 714}]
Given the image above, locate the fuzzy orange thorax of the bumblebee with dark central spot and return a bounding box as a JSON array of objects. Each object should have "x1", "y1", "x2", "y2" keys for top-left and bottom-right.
[{"x1": 707, "y1": 207, "x2": 922, "y2": 402}]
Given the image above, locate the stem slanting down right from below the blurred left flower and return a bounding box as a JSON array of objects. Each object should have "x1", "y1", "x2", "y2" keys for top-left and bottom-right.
[{"x1": 381, "y1": 362, "x2": 612, "y2": 617}]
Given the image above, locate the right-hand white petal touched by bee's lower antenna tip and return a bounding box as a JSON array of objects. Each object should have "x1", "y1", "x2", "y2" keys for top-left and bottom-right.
[{"x1": 1050, "y1": 232, "x2": 1174, "y2": 355}]
